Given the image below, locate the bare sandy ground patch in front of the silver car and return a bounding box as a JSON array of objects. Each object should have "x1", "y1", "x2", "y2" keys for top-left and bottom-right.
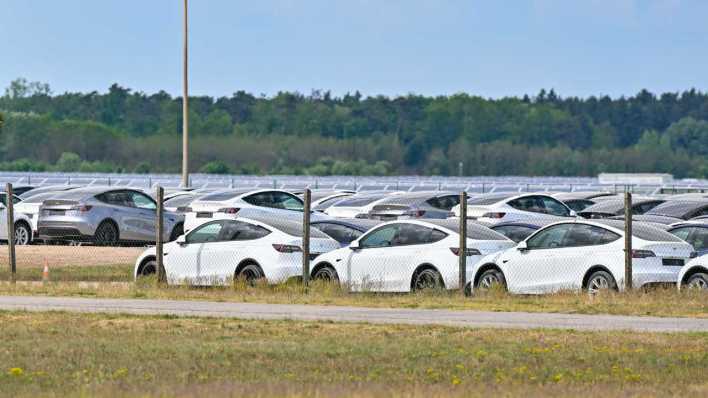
[{"x1": 0, "y1": 245, "x2": 145, "y2": 268}]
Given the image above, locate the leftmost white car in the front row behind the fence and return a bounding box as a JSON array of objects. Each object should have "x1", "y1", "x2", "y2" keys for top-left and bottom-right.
[{"x1": 135, "y1": 218, "x2": 339, "y2": 285}]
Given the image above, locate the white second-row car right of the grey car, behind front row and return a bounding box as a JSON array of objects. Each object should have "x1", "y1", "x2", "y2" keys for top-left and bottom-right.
[{"x1": 453, "y1": 193, "x2": 576, "y2": 224}]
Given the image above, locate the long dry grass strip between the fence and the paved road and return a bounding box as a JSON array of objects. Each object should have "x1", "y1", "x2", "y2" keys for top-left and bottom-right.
[{"x1": 0, "y1": 280, "x2": 708, "y2": 318}]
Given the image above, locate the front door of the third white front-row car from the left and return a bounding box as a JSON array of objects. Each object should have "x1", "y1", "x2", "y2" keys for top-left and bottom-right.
[{"x1": 499, "y1": 223, "x2": 573, "y2": 293}]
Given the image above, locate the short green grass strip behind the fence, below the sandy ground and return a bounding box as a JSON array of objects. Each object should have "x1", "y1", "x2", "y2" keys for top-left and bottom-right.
[{"x1": 0, "y1": 265, "x2": 133, "y2": 282}]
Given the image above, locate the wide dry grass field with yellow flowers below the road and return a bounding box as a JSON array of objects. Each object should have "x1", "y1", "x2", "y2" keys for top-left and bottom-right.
[{"x1": 0, "y1": 312, "x2": 708, "y2": 397}]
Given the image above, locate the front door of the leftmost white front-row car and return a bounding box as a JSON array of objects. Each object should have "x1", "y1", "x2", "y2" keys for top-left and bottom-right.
[{"x1": 164, "y1": 220, "x2": 225, "y2": 285}]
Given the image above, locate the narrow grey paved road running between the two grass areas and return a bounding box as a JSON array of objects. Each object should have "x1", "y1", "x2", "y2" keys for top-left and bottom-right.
[{"x1": 0, "y1": 296, "x2": 708, "y2": 332}]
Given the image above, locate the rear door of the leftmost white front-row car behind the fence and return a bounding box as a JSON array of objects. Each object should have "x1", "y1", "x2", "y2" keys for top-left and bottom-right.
[{"x1": 199, "y1": 220, "x2": 271, "y2": 284}]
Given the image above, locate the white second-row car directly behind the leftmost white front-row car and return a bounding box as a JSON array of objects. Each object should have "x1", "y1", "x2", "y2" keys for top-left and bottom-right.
[{"x1": 184, "y1": 188, "x2": 303, "y2": 231}]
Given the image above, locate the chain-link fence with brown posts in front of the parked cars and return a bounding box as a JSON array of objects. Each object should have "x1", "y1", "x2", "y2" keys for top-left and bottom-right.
[{"x1": 0, "y1": 185, "x2": 694, "y2": 294}]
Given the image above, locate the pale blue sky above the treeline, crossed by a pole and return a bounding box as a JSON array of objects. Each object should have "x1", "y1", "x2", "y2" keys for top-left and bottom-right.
[{"x1": 0, "y1": 0, "x2": 708, "y2": 98}]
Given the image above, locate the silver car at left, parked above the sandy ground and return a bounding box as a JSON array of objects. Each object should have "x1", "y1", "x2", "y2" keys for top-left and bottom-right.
[{"x1": 37, "y1": 187, "x2": 184, "y2": 246}]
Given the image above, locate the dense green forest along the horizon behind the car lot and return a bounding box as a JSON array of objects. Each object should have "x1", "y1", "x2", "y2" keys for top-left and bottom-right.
[{"x1": 0, "y1": 78, "x2": 708, "y2": 178}]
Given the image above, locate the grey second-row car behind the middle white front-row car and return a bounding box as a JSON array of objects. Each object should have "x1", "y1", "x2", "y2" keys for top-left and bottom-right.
[{"x1": 367, "y1": 191, "x2": 460, "y2": 221}]
